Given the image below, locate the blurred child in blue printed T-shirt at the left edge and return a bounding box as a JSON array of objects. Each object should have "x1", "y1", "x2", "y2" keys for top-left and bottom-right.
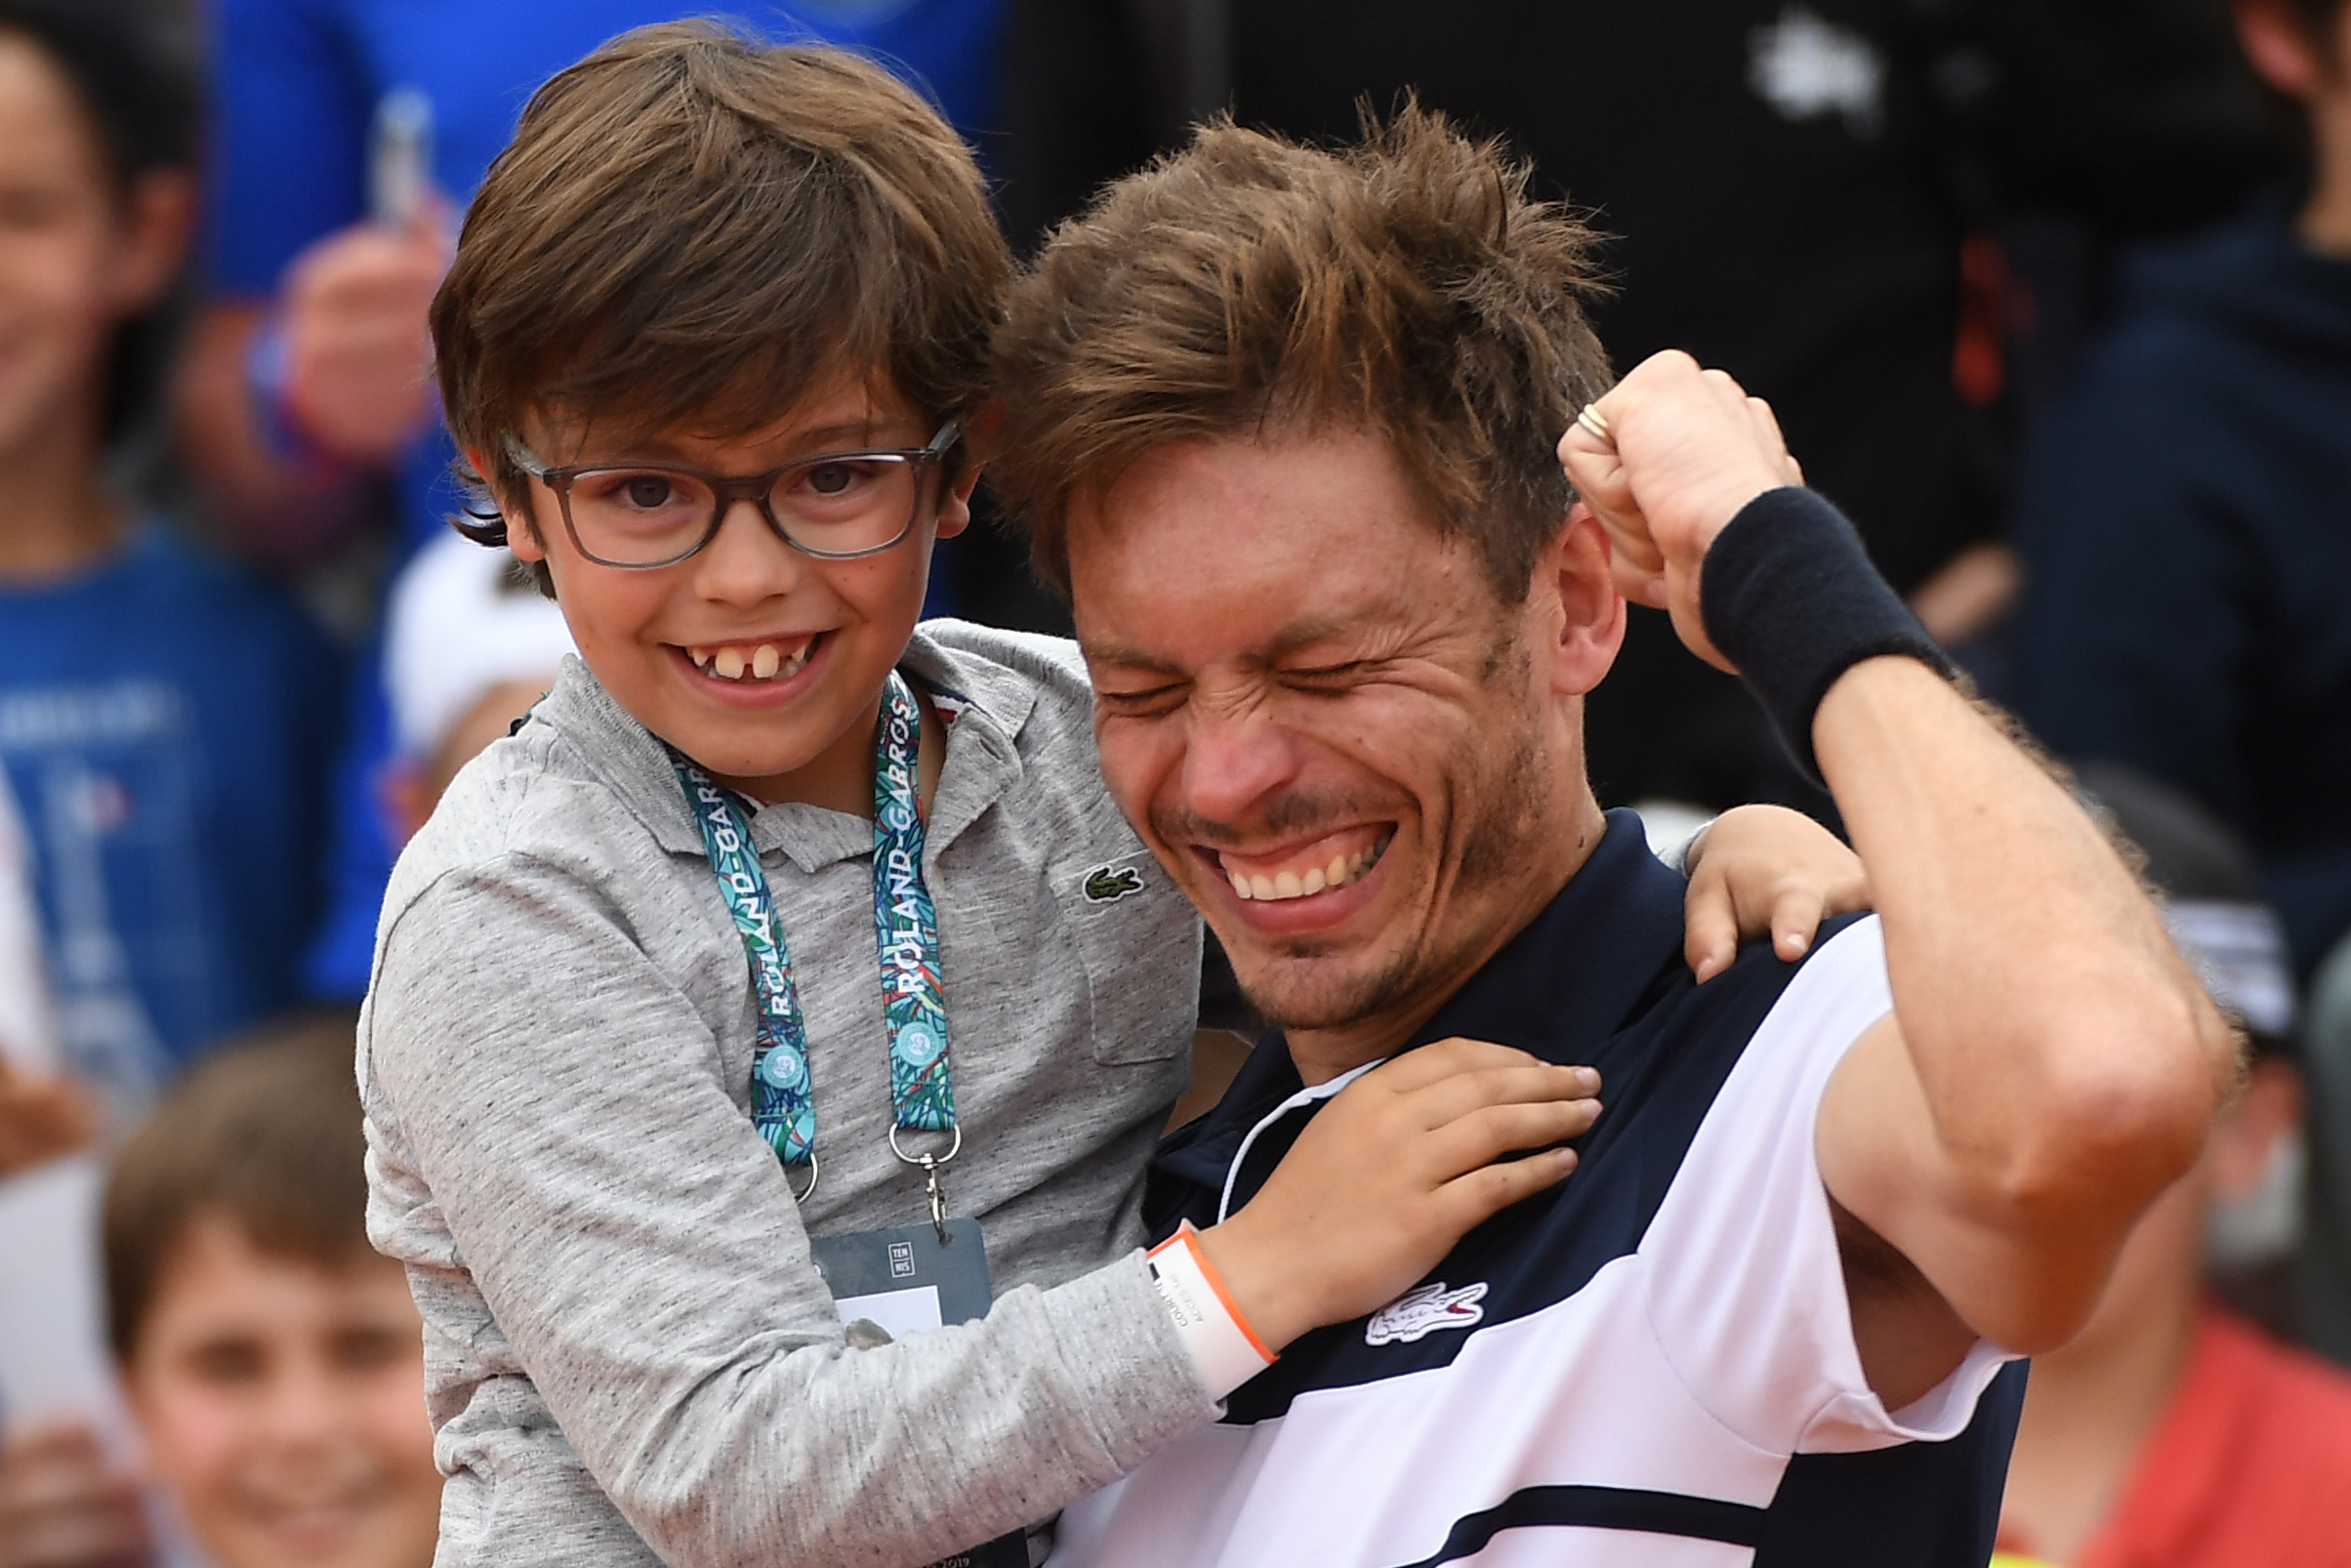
[{"x1": 0, "y1": 0, "x2": 336, "y2": 1122}]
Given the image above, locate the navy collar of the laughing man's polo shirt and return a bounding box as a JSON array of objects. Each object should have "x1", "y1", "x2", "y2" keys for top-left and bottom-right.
[{"x1": 1152, "y1": 808, "x2": 1683, "y2": 1189}]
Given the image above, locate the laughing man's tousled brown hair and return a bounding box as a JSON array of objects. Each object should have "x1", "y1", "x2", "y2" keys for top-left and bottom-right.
[{"x1": 990, "y1": 105, "x2": 1608, "y2": 604}]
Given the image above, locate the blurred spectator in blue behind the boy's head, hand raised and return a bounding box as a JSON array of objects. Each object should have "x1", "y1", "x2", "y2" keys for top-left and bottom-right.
[{"x1": 163, "y1": 0, "x2": 1002, "y2": 999}]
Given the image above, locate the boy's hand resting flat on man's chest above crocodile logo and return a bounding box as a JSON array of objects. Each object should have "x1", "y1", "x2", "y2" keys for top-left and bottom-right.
[{"x1": 1201, "y1": 1039, "x2": 1601, "y2": 1349}]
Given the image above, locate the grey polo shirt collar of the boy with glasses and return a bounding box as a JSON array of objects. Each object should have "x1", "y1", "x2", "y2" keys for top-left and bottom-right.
[{"x1": 531, "y1": 630, "x2": 1037, "y2": 875}]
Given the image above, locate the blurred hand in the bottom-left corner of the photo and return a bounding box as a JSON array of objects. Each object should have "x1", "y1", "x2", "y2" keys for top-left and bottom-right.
[{"x1": 0, "y1": 1423, "x2": 155, "y2": 1568}]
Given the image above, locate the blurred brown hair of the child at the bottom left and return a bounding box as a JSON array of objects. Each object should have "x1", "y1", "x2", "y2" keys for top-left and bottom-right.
[{"x1": 103, "y1": 1009, "x2": 374, "y2": 1361}]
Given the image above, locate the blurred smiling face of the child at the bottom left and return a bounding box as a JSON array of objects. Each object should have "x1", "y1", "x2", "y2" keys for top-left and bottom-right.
[{"x1": 125, "y1": 1213, "x2": 439, "y2": 1568}]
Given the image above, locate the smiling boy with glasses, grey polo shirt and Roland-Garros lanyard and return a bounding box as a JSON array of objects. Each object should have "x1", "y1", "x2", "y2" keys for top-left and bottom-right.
[{"x1": 359, "y1": 25, "x2": 1862, "y2": 1566}]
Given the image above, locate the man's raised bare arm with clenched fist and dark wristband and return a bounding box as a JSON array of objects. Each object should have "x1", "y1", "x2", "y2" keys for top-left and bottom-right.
[{"x1": 1561, "y1": 355, "x2": 2236, "y2": 1408}]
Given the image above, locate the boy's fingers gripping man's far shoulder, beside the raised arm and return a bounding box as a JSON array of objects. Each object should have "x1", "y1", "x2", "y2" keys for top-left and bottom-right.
[{"x1": 1681, "y1": 806, "x2": 1872, "y2": 980}]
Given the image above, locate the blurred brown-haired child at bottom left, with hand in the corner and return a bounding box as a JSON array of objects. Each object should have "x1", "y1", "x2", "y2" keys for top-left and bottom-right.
[{"x1": 0, "y1": 1011, "x2": 439, "y2": 1568}]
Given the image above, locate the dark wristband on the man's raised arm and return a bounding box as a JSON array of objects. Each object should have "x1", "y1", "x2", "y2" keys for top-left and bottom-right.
[{"x1": 1698, "y1": 486, "x2": 1959, "y2": 780}]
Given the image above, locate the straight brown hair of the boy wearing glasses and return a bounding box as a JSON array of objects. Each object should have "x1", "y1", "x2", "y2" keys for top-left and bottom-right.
[{"x1": 433, "y1": 21, "x2": 1011, "y2": 543}]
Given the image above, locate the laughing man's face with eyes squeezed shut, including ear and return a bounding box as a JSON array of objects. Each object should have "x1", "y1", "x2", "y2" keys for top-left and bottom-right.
[{"x1": 1070, "y1": 433, "x2": 1623, "y2": 1032}]
